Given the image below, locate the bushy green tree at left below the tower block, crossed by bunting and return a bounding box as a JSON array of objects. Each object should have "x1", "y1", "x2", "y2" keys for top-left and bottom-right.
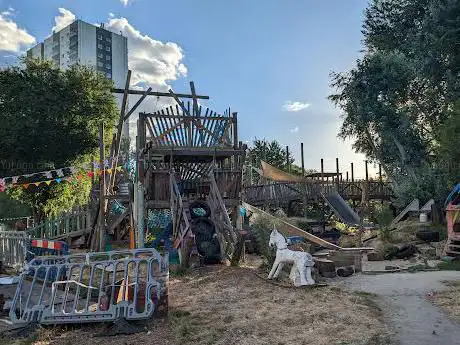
[{"x1": 0, "y1": 59, "x2": 118, "y2": 219}]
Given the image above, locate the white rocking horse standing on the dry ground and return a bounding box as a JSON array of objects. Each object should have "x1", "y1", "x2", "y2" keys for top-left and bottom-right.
[{"x1": 268, "y1": 228, "x2": 315, "y2": 286}]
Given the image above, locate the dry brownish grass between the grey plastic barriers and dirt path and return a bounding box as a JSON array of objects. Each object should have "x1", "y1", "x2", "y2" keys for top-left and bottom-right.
[{"x1": 10, "y1": 258, "x2": 388, "y2": 345}]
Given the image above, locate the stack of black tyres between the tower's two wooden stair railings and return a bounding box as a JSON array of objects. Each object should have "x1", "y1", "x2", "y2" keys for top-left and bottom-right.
[{"x1": 189, "y1": 201, "x2": 220, "y2": 263}]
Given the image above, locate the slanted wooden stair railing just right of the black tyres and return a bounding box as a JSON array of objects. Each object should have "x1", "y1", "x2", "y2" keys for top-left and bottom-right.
[{"x1": 208, "y1": 172, "x2": 238, "y2": 258}]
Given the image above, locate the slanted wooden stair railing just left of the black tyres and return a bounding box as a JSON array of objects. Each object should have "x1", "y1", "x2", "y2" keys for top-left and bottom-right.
[{"x1": 169, "y1": 174, "x2": 190, "y2": 248}]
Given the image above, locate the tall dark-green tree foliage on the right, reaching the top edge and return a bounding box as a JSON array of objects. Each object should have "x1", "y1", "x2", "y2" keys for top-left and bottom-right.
[{"x1": 329, "y1": 0, "x2": 460, "y2": 204}]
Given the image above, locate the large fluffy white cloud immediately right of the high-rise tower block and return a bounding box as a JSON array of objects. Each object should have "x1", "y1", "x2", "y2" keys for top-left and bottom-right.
[{"x1": 106, "y1": 18, "x2": 187, "y2": 87}]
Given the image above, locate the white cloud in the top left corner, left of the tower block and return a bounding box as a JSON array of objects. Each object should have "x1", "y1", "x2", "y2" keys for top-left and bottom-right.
[{"x1": 0, "y1": 7, "x2": 36, "y2": 53}]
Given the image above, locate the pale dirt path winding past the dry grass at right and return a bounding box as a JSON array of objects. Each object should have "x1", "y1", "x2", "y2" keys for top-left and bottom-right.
[{"x1": 334, "y1": 272, "x2": 460, "y2": 345}]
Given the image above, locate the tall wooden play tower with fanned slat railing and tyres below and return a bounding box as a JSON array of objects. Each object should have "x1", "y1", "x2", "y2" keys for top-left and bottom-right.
[{"x1": 134, "y1": 82, "x2": 246, "y2": 262}]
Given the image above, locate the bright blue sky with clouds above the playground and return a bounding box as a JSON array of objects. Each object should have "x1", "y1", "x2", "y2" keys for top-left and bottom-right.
[{"x1": 0, "y1": 0, "x2": 378, "y2": 176}]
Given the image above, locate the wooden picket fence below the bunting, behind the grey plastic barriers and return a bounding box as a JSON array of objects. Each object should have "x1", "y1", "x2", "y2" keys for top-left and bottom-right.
[{"x1": 26, "y1": 207, "x2": 92, "y2": 239}]
